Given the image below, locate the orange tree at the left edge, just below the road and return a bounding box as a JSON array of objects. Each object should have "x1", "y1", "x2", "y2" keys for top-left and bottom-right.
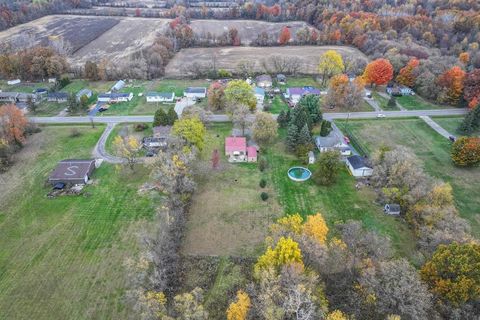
[{"x1": 0, "y1": 104, "x2": 28, "y2": 144}]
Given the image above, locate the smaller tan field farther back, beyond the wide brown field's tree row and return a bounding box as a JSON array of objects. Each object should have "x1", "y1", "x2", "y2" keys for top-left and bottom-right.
[{"x1": 190, "y1": 20, "x2": 318, "y2": 45}]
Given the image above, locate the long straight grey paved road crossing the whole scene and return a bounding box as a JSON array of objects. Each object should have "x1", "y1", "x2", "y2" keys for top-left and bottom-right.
[{"x1": 30, "y1": 108, "x2": 468, "y2": 124}]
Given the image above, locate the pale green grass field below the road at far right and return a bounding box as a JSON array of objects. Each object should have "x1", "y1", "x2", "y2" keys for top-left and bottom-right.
[{"x1": 348, "y1": 119, "x2": 480, "y2": 237}]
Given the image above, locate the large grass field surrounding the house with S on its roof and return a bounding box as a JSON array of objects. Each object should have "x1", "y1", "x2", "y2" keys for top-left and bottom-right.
[{"x1": 0, "y1": 126, "x2": 153, "y2": 319}]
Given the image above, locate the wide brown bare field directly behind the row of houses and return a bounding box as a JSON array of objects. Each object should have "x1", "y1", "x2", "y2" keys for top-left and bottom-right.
[{"x1": 165, "y1": 46, "x2": 367, "y2": 77}]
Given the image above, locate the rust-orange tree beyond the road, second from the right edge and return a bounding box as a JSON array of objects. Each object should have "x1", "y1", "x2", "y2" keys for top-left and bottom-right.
[{"x1": 437, "y1": 66, "x2": 465, "y2": 104}]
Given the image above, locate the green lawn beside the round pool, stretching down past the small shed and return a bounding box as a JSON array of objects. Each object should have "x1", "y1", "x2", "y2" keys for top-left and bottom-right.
[{"x1": 265, "y1": 136, "x2": 414, "y2": 257}]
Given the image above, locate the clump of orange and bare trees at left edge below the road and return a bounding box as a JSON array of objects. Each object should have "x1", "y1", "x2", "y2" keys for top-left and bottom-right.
[{"x1": 0, "y1": 104, "x2": 39, "y2": 173}]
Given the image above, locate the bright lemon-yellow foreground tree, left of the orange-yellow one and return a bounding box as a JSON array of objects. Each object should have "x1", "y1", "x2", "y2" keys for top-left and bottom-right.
[{"x1": 255, "y1": 237, "x2": 303, "y2": 274}]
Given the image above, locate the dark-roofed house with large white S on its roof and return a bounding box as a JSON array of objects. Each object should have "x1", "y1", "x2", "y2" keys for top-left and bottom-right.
[{"x1": 48, "y1": 159, "x2": 95, "y2": 185}]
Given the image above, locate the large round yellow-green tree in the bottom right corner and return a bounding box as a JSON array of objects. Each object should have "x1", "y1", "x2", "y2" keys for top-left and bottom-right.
[{"x1": 420, "y1": 243, "x2": 480, "y2": 306}]
